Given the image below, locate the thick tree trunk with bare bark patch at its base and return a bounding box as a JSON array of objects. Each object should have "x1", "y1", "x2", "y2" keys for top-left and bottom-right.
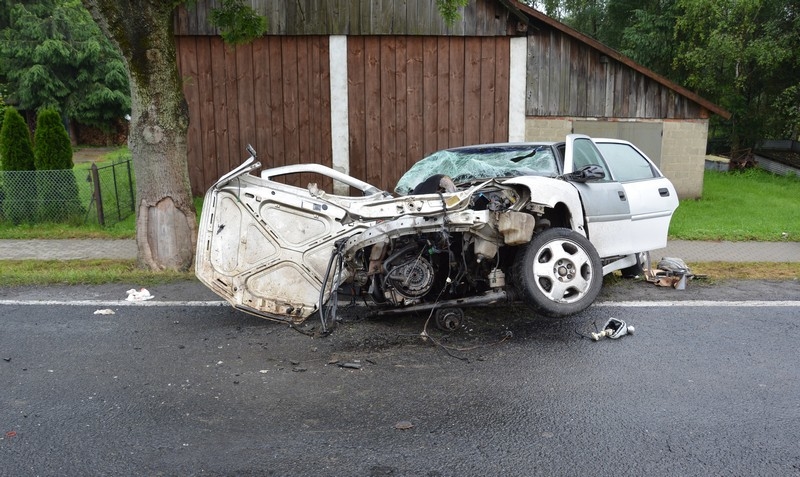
[{"x1": 82, "y1": 0, "x2": 197, "y2": 271}]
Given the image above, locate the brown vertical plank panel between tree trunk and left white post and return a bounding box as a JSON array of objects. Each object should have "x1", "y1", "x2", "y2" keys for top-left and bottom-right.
[{"x1": 177, "y1": 36, "x2": 332, "y2": 195}]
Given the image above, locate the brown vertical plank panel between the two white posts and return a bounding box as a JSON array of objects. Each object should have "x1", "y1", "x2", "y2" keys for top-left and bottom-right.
[{"x1": 348, "y1": 36, "x2": 510, "y2": 191}]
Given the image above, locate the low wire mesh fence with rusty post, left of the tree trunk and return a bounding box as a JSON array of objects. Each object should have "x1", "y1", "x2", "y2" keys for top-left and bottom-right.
[{"x1": 0, "y1": 159, "x2": 136, "y2": 225}]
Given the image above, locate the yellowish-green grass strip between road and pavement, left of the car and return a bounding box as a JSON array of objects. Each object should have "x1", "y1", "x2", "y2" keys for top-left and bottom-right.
[{"x1": 0, "y1": 260, "x2": 194, "y2": 287}]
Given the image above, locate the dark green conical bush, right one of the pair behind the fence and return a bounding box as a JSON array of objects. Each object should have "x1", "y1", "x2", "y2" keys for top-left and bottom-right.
[{"x1": 33, "y1": 109, "x2": 86, "y2": 222}]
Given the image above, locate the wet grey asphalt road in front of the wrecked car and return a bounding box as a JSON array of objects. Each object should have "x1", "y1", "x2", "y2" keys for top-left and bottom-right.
[{"x1": 0, "y1": 282, "x2": 800, "y2": 476}]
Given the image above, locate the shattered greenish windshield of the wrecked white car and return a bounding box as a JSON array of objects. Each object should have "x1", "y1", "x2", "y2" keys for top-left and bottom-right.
[{"x1": 395, "y1": 144, "x2": 558, "y2": 195}]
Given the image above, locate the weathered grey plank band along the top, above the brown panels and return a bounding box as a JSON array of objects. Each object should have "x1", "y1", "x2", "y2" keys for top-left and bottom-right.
[{"x1": 174, "y1": 0, "x2": 516, "y2": 36}]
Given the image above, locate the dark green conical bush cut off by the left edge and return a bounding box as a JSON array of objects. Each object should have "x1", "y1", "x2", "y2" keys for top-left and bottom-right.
[{"x1": 0, "y1": 107, "x2": 36, "y2": 224}]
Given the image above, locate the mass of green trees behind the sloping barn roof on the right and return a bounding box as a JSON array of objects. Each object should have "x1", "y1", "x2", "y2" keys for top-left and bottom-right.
[{"x1": 522, "y1": 0, "x2": 800, "y2": 149}]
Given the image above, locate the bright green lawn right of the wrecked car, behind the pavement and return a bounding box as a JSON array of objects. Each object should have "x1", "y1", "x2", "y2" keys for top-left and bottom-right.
[{"x1": 669, "y1": 169, "x2": 800, "y2": 242}]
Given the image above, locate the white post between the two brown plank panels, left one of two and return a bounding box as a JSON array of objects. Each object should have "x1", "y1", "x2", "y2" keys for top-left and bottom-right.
[{"x1": 328, "y1": 35, "x2": 350, "y2": 195}]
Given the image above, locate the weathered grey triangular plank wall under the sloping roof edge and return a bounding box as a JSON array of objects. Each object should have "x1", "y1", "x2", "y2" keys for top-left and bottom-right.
[{"x1": 525, "y1": 27, "x2": 707, "y2": 119}]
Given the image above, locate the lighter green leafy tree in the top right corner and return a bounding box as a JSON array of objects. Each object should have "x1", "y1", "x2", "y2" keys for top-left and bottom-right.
[{"x1": 675, "y1": 0, "x2": 800, "y2": 149}]
